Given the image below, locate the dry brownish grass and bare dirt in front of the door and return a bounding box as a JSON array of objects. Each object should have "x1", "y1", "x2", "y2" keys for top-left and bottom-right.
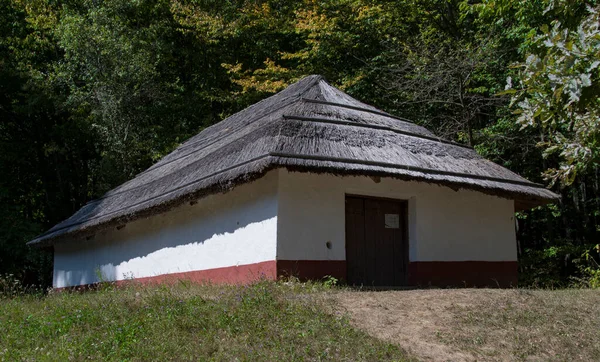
[{"x1": 332, "y1": 289, "x2": 600, "y2": 361}]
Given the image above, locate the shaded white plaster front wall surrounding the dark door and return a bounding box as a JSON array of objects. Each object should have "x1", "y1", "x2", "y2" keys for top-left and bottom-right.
[{"x1": 277, "y1": 170, "x2": 517, "y2": 261}]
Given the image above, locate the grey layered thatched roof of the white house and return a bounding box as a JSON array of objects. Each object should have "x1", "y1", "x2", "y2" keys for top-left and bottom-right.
[{"x1": 30, "y1": 75, "x2": 557, "y2": 245}]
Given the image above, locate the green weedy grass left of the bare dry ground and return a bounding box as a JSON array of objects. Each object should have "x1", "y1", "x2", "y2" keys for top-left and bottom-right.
[{"x1": 0, "y1": 281, "x2": 405, "y2": 361}]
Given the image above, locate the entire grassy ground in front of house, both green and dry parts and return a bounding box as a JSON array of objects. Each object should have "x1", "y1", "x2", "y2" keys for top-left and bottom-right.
[{"x1": 0, "y1": 281, "x2": 600, "y2": 361}]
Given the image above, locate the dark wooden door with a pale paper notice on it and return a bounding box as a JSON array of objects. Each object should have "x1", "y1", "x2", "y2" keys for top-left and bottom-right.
[{"x1": 346, "y1": 196, "x2": 408, "y2": 286}]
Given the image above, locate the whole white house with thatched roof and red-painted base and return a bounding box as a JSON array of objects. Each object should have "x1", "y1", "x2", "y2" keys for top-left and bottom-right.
[{"x1": 30, "y1": 76, "x2": 557, "y2": 288}]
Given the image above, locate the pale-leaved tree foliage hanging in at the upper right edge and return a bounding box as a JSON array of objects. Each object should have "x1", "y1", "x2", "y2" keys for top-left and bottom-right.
[{"x1": 507, "y1": 4, "x2": 600, "y2": 185}]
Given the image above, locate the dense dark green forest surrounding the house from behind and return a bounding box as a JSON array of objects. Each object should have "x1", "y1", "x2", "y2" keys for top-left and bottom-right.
[{"x1": 0, "y1": 0, "x2": 600, "y2": 287}]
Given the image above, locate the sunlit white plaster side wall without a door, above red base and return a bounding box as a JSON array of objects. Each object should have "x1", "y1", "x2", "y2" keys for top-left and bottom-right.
[{"x1": 53, "y1": 171, "x2": 278, "y2": 288}]
